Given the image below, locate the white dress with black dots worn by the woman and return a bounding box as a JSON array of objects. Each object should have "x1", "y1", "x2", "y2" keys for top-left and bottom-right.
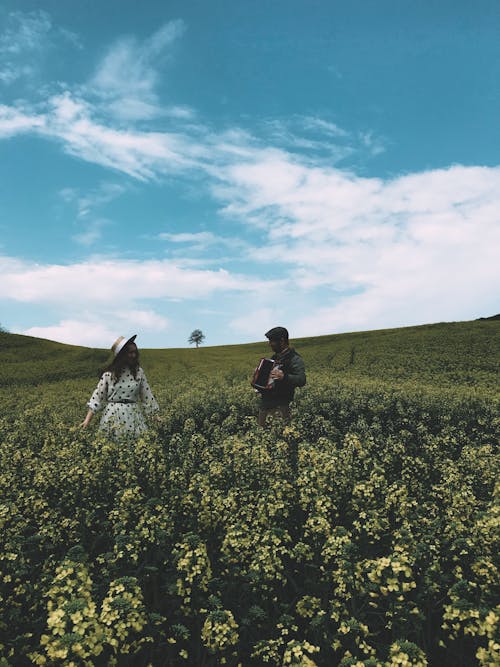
[{"x1": 87, "y1": 368, "x2": 159, "y2": 436}]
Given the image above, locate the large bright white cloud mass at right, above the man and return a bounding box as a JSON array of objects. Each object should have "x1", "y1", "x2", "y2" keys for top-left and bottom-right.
[{"x1": 221, "y1": 156, "x2": 500, "y2": 335}]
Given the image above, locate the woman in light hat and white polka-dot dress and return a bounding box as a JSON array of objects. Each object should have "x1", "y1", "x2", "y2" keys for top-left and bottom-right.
[{"x1": 81, "y1": 336, "x2": 159, "y2": 437}]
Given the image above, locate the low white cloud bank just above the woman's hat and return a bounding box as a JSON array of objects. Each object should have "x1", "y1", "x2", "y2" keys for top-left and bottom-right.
[{"x1": 0, "y1": 257, "x2": 274, "y2": 347}]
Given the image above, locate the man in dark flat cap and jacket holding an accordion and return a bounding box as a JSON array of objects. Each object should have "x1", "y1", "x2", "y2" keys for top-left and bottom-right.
[{"x1": 259, "y1": 327, "x2": 306, "y2": 426}]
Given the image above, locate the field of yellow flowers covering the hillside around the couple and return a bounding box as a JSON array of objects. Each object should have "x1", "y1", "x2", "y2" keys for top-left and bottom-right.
[{"x1": 0, "y1": 321, "x2": 500, "y2": 667}]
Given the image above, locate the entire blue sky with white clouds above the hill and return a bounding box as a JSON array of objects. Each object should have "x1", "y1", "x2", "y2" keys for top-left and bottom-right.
[{"x1": 0, "y1": 0, "x2": 500, "y2": 347}]
